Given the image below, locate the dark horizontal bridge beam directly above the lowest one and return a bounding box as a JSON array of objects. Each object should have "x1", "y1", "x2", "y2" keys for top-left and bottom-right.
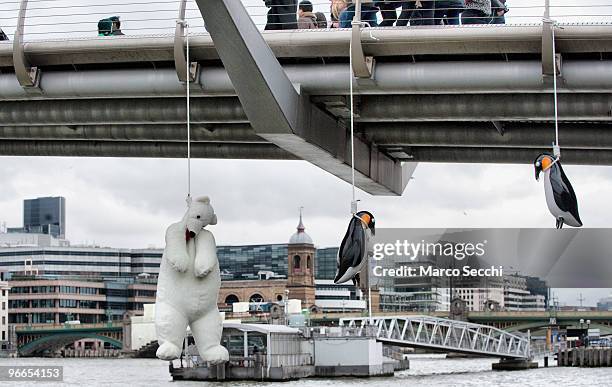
[{"x1": 0, "y1": 122, "x2": 612, "y2": 150}]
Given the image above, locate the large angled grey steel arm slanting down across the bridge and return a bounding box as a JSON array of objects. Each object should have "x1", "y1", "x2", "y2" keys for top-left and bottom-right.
[{"x1": 191, "y1": 0, "x2": 411, "y2": 195}]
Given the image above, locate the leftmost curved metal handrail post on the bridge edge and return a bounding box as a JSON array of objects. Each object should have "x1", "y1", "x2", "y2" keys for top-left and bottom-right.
[{"x1": 13, "y1": 0, "x2": 41, "y2": 93}]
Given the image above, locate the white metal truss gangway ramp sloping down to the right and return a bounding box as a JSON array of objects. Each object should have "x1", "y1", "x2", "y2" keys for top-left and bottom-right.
[{"x1": 340, "y1": 316, "x2": 531, "y2": 359}]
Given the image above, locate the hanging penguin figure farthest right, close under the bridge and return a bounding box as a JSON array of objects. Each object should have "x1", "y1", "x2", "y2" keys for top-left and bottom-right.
[{"x1": 534, "y1": 153, "x2": 582, "y2": 229}]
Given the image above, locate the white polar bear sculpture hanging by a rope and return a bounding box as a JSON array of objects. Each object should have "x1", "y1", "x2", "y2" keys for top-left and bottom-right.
[{"x1": 155, "y1": 197, "x2": 229, "y2": 364}]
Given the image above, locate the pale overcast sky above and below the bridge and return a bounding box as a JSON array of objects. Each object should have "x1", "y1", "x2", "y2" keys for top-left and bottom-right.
[{"x1": 0, "y1": 0, "x2": 612, "y2": 304}]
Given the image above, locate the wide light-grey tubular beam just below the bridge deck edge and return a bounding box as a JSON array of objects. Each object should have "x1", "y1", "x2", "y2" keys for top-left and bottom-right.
[{"x1": 0, "y1": 59, "x2": 612, "y2": 100}]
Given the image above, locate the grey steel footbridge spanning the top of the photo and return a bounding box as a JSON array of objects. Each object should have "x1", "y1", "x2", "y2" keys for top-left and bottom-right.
[{"x1": 0, "y1": 0, "x2": 612, "y2": 195}]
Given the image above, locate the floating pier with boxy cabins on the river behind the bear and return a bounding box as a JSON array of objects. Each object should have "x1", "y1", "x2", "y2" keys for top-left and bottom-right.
[{"x1": 170, "y1": 323, "x2": 410, "y2": 381}]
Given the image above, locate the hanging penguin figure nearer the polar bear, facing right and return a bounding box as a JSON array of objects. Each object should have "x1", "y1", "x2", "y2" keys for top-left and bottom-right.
[{"x1": 334, "y1": 211, "x2": 376, "y2": 286}]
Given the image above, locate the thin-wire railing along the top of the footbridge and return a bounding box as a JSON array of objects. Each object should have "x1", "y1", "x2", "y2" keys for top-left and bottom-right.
[{"x1": 0, "y1": 0, "x2": 612, "y2": 42}]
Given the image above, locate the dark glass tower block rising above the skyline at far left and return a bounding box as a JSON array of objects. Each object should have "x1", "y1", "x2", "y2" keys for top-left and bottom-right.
[{"x1": 8, "y1": 197, "x2": 66, "y2": 239}]
